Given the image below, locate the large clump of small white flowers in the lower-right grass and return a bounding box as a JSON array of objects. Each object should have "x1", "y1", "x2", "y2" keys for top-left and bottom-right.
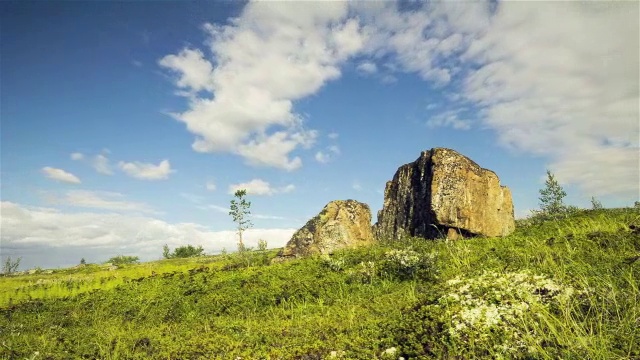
[{"x1": 437, "y1": 272, "x2": 574, "y2": 355}]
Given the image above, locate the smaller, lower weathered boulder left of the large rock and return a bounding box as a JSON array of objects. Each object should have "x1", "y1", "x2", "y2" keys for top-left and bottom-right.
[{"x1": 278, "y1": 200, "x2": 373, "y2": 258}]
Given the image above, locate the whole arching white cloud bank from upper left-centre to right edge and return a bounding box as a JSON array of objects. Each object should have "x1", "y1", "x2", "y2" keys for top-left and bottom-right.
[{"x1": 160, "y1": 1, "x2": 640, "y2": 198}]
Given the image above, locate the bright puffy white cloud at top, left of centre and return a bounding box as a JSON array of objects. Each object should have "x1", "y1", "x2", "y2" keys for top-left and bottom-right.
[{"x1": 159, "y1": 2, "x2": 364, "y2": 170}]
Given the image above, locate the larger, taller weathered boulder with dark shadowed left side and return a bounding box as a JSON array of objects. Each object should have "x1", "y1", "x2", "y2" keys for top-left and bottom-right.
[{"x1": 374, "y1": 148, "x2": 515, "y2": 239}]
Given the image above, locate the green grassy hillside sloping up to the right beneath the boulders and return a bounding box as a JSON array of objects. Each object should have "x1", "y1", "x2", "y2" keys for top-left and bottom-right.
[{"x1": 0, "y1": 209, "x2": 640, "y2": 359}]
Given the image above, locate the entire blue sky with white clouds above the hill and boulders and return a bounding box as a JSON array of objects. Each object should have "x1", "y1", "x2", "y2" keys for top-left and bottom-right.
[{"x1": 0, "y1": 1, "x2": 640, "y2": 268}]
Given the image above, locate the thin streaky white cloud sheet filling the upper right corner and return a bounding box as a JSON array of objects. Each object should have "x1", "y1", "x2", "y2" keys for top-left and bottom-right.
[{"x1": 354, "y1": 2, "x2": 640, "y2": 198}]
